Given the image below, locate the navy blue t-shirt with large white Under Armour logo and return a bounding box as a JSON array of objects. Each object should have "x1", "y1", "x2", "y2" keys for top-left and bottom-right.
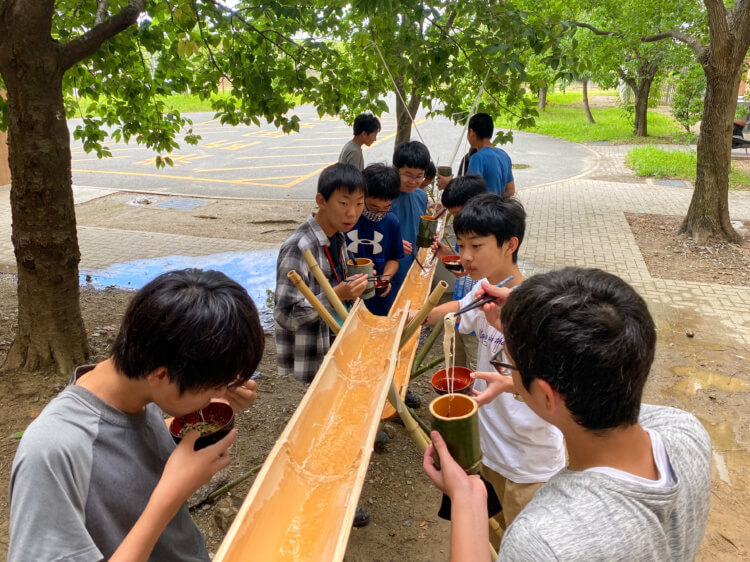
[{"x1": 346, "y1": 213, "x2": 404, "y2": 316}]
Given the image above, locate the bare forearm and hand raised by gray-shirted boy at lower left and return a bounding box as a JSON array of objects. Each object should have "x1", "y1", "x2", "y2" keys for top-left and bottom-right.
[{"x1": 110, "y1": 430, "x2": 237, "y2": 562}]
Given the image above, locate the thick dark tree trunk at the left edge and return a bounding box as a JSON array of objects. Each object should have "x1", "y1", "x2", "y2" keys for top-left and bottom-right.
[{"x1": 0, "y1": 42, "x2": 89, "y2": 373}]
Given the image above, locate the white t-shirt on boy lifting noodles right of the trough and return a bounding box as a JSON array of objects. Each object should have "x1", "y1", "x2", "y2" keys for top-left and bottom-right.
[{"x1": 459, "y1": 283, "x2": 565, "y2": 484}]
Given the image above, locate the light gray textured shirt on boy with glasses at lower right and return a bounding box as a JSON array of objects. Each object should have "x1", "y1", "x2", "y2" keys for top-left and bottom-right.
[{"x1": 498, "y1": 405, "x2": 711, "y2": 562}]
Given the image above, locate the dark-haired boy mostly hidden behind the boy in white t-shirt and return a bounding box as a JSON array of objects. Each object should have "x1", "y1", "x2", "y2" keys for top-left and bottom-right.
[{"x1": 435, "y1": 174, "x2": 487, "y2": 371}]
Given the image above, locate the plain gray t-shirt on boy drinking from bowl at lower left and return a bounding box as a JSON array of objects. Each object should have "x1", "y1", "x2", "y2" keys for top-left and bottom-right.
[{"x1": 8, "y1": 366, "x2": 209, "y2": 562}]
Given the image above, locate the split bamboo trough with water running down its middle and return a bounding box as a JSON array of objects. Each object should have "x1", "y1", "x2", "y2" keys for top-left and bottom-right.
[{"x1": 214, "y1": 238, "x2": 444, "y2": 562}]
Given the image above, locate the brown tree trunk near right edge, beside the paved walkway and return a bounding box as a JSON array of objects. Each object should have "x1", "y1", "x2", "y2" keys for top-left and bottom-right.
[{"x1": 680, "y1": 61, "x2": 742, "y2": 244}]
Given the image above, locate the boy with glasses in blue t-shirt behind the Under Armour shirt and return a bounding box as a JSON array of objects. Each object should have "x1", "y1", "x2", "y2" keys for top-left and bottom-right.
[{"x1": 391, "y1": 141, "x2": 430, "y2": 293}]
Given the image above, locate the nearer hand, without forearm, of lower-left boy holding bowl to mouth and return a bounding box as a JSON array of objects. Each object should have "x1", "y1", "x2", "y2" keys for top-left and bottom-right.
[{"x1": 160, "y1": 429, "x2": 237, "y2": 505}]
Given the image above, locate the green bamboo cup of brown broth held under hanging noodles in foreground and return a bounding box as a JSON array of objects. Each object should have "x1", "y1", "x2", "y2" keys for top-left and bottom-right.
[{"x1": 430, "y1": 394, "x2": 482, "y2": 474}]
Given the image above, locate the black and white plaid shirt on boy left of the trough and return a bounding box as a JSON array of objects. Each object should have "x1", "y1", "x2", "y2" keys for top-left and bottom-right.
[{"x1": 273, "y1": 215, "x2": 349, "y2": 382}]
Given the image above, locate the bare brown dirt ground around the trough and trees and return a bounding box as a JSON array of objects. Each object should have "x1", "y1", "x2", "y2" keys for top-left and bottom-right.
[{"x1": 0, "y1": 194, "x2": 750, "y2": 561}]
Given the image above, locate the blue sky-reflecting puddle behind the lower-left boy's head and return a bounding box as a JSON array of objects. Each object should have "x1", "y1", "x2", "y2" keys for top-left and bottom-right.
[{"x1": 80, "y1": 250, "x2": 279, "y2": 329}]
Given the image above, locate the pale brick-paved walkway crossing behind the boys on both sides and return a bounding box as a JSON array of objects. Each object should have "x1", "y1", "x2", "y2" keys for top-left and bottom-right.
[{"x1": 0, "y1": 139, "x2": 750, "y2": 345}]
